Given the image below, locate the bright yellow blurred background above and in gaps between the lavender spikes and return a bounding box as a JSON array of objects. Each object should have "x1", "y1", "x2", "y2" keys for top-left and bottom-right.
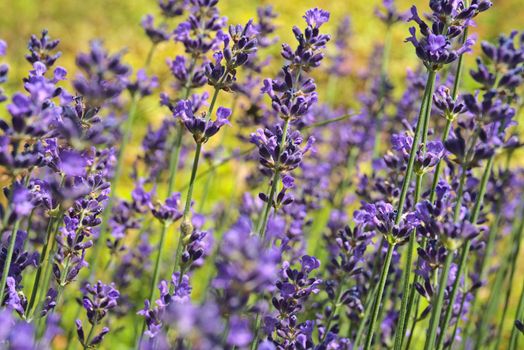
[{"x1": 0, "y1": 0, "x2": 524, "y2": 348}]
